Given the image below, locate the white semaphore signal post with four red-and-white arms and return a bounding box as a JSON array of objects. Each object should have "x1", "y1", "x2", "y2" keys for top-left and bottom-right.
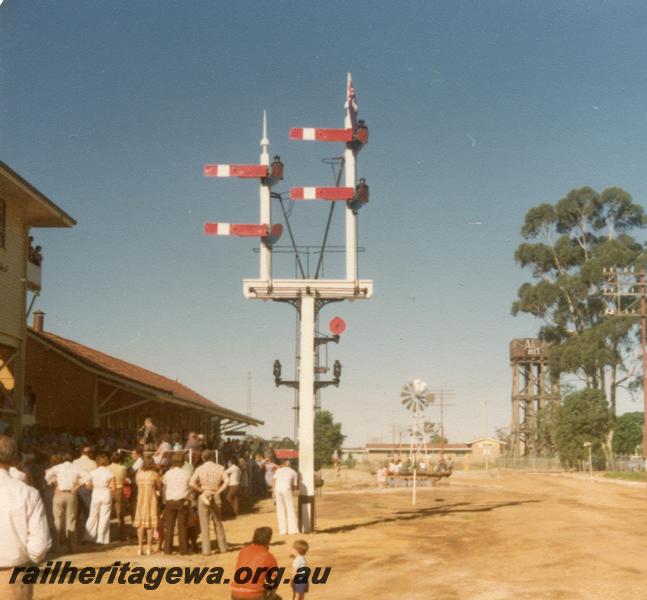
[{"x1": 204, "y1": 73, "x2": 373, "y2": 533}]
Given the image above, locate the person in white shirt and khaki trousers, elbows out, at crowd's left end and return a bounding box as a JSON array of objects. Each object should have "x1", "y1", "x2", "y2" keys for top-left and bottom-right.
[{"x1": 45, "y1": 454, "x2": 89, "y2": 552}]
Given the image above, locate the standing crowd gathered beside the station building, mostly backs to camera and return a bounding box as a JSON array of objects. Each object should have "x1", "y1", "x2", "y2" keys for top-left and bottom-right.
[{"x1": 10, "y1": 419, "x2": 298, "y2": 554}]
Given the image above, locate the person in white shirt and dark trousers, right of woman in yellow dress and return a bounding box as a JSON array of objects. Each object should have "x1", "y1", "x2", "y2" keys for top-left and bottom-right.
[{"x1": 162, "y1": 452, "x2": 191, "y2": 554}]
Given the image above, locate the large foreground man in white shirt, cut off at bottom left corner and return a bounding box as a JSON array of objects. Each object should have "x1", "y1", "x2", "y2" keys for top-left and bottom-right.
[{"x1": 0, "y1": 435, "x2": 52, "y2": 600}]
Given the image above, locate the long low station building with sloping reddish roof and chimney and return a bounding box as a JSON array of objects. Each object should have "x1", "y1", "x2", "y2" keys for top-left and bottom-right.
[{"x1": 26, "y1": 313, "x2": 263, "y2": 439}]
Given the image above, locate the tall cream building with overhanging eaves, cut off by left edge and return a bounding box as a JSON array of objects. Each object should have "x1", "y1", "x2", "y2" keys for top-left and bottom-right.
[{"x1": 0, "y1": 162, "x2": 76, "y2": 435}]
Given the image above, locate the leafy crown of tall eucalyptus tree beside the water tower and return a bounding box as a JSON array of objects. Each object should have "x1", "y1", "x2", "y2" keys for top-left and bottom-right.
[{"x1": 512, "y1": 187, "x2": 647, "y2": 414}]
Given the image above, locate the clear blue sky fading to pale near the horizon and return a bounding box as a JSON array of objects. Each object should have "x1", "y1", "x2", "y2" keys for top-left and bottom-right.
[{"x1": 0, "y1": 0, "x2": 647, "y2": 444}]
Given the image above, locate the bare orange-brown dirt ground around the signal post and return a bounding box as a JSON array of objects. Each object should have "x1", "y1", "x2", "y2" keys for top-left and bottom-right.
[{"x1": 34, "y1": 473, "x2": 647, "y2": 600}]
